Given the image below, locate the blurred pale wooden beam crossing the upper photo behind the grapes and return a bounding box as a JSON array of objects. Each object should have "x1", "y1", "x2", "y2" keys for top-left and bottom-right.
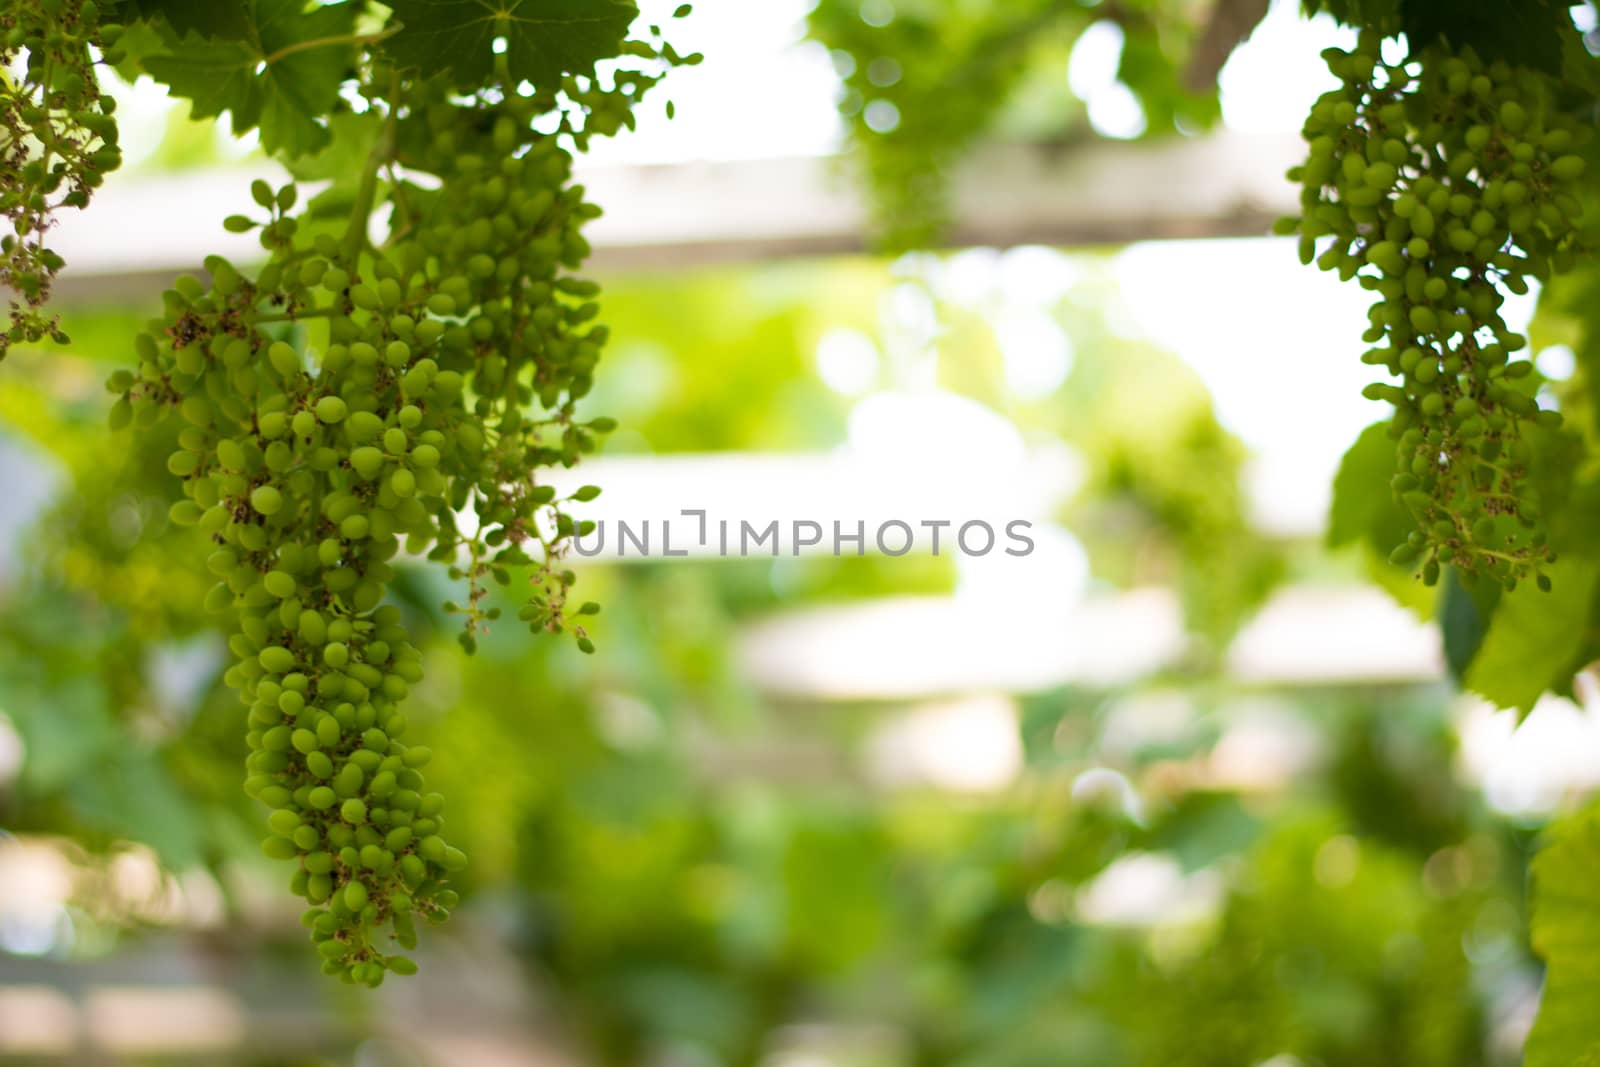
[{"x1": 37, "y1": 133, "x2": 1302, "y2": 302}]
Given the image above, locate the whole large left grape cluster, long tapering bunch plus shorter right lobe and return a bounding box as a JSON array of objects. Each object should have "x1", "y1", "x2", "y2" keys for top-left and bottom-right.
[{"x1": 110, "y1": 98, "x2": 611, "y2": 985}]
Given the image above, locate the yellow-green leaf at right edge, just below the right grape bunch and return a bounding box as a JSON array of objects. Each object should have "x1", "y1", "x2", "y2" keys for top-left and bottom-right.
[{"x1": 1467, "y1": 557, "x2": 1600, "y2": 713}]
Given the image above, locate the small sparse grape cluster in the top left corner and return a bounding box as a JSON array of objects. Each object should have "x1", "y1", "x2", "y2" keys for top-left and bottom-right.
[{"x1": 0, "y1": 0, "x2": 122, "y2": 358}]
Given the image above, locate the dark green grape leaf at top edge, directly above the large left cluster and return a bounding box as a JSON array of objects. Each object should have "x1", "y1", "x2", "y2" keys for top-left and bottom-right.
[{"x1": 384, "y1": 0, "x2": 638, "y2": 90}]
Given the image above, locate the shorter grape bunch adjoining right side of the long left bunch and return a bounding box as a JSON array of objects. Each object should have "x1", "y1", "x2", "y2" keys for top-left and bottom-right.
[{"x1": 397, "y1": 98, "x2": 616, "y2": 653}]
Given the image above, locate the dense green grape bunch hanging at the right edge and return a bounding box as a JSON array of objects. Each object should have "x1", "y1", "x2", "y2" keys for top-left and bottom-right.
[{"x1": 1278, "y1": 32, "x2": 1587, "y2": 589}]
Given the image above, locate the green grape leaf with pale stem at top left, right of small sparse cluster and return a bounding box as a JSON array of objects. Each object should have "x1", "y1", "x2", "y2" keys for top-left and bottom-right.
[{"x1": 144, "y1": 0, "x2": 357, "y2": 157}]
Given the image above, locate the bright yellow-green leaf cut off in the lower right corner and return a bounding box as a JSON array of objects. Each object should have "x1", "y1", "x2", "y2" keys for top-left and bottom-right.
[{"x1": 1523, "y1": 806, "x2": 1600, "y2": 1067}]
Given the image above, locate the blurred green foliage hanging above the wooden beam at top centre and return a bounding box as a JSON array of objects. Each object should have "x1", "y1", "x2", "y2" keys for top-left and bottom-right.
[{"x1": 808, "y1": 0, "x2": 1216, "y2": 251}]
